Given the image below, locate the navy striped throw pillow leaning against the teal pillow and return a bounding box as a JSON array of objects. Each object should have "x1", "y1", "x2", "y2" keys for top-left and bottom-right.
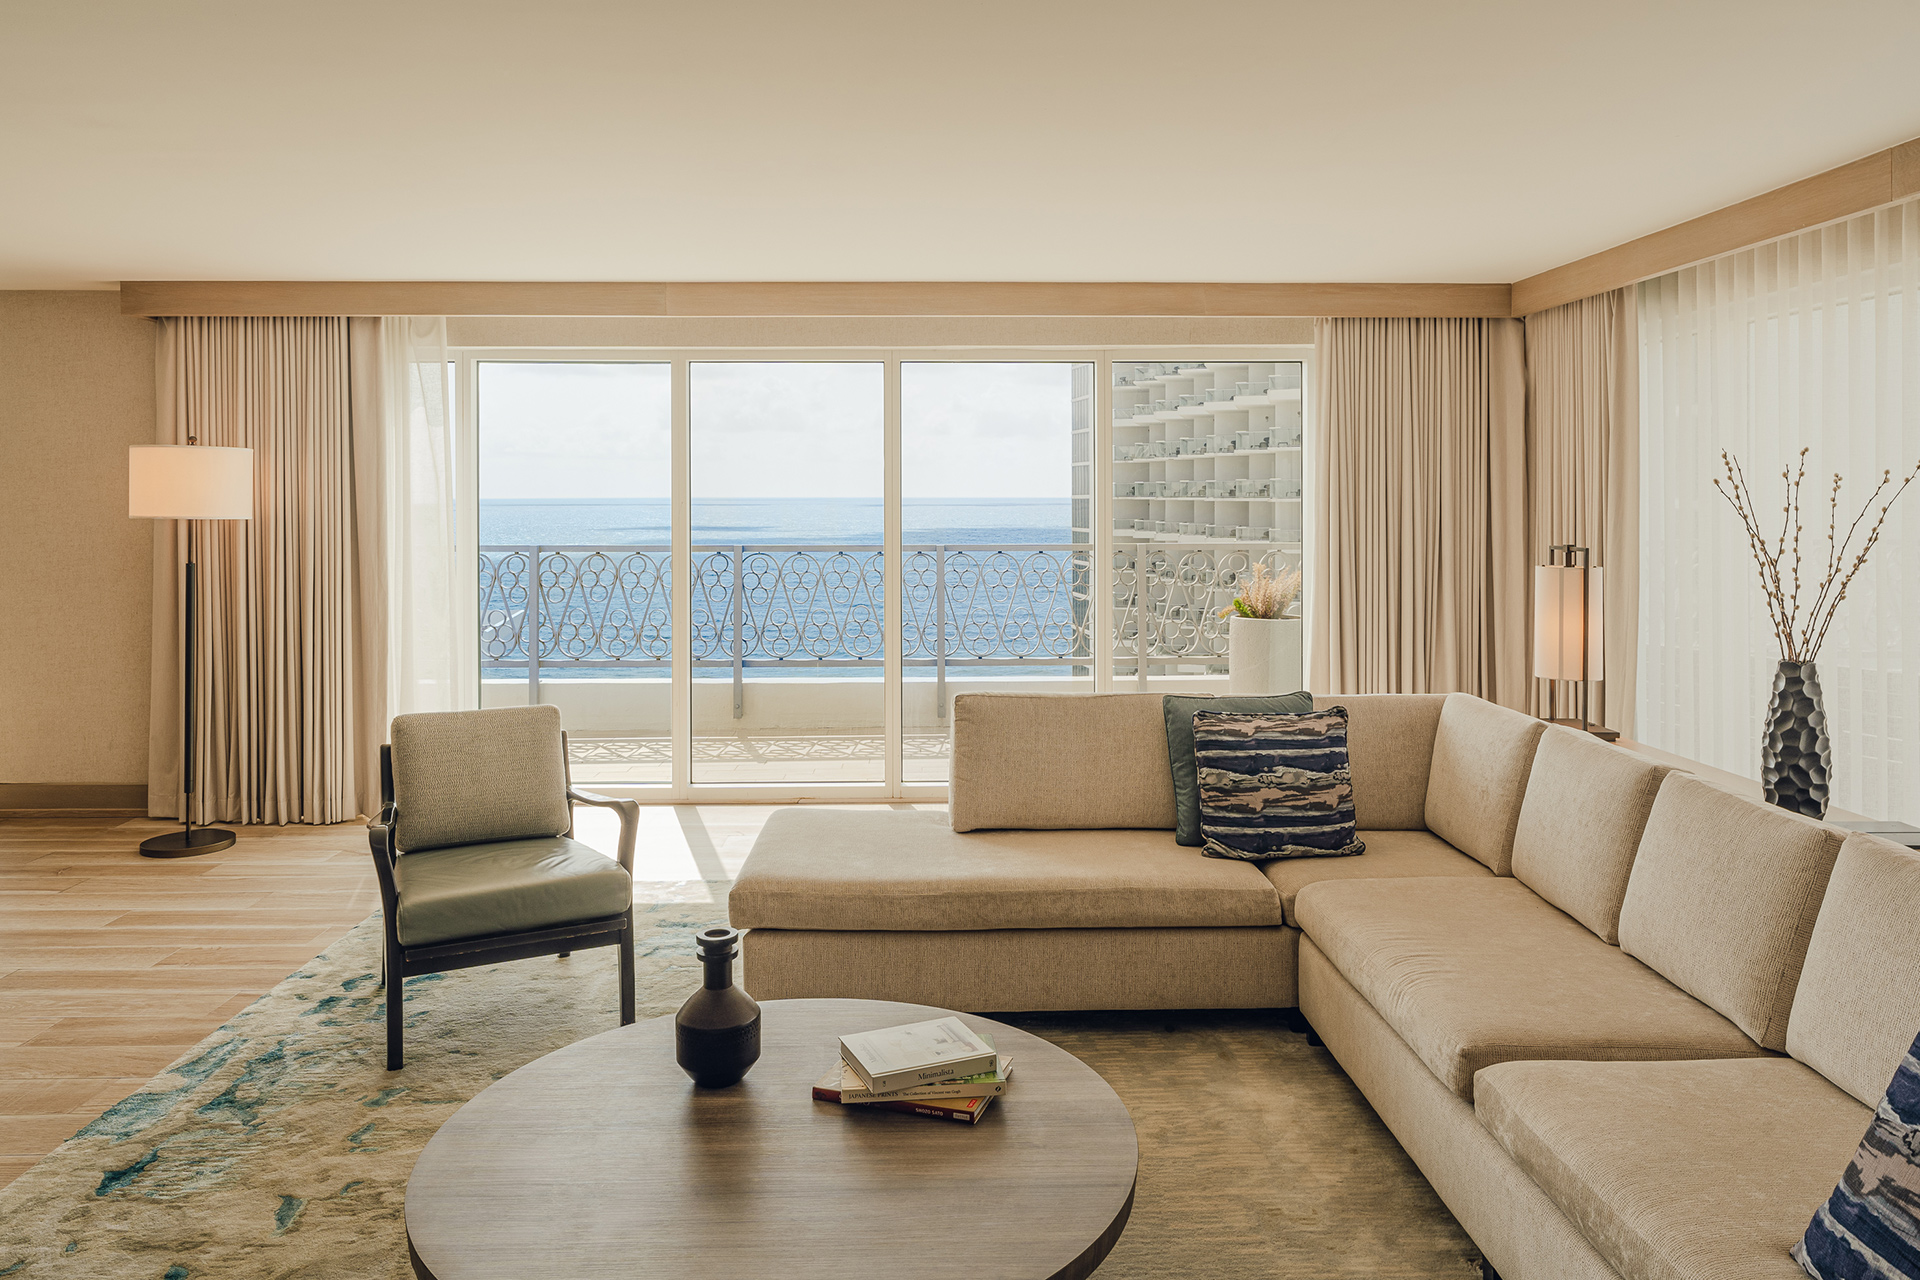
[{"x1": 1194, "y1": 706, "x2": 1367, "y2": 862}]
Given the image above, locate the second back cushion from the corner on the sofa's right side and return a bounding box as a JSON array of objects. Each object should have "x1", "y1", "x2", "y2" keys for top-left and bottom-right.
[{"x1": 1513, "y1": 725, "x2": 1670, "y2": 942}]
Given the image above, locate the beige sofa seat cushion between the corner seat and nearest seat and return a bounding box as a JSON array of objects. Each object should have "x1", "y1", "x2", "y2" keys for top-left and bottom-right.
[{"x1": 1294, "y1": 877, "x2": 1764, "y2": 1100}]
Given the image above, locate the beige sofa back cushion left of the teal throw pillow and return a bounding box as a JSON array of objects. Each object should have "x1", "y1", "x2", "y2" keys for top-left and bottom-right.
[{"x1": 948, "y1": 693, "x2": 1173, "y2": 831}]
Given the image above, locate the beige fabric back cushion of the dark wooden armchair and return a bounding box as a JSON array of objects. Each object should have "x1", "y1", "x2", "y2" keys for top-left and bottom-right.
[{"x1": 390, "y1": 706, "x2": 572, "y2": 854}]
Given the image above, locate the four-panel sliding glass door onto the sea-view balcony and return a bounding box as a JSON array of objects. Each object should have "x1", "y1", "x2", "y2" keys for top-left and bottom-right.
[{"x1": 457, "y1": 347, "x2": 1313, "y2": 800}]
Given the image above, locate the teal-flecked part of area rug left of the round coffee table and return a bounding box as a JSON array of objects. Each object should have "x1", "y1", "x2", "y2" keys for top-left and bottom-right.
[{"x1": 0, "y1": 883, "x2": 728, "y2": 1280}]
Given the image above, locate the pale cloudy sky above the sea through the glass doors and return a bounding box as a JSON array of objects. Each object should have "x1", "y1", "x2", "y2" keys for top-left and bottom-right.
[{"x1": 480, "y1": 361, "x2": 1073, "y2": 501}]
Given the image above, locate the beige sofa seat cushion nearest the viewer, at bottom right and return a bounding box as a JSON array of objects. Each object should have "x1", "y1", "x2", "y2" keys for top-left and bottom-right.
[{"x1": 1475, "y1": 1057, "x2": 1872, "y2": 1280}]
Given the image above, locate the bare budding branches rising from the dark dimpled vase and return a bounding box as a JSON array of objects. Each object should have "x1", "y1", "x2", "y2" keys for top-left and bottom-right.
[{"x1": 1713, "y1": 449, "x2": 1920, "y2": 662}]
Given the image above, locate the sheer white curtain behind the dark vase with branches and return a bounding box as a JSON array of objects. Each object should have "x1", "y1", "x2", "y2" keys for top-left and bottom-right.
[{"x1": 1638, "y1": 201, "x2": 1920, "y2": 821}]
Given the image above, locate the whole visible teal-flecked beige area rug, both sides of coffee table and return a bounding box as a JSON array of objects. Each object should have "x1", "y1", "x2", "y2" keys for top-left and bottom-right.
[{"x1": 0, "y1": 881, "x2": 1480, "y2": 1280}]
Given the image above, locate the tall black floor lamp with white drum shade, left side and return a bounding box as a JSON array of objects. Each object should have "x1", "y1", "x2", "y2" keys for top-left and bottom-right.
[{"x1": 127, "y1": 436, "x2": 253, "y2": 858}]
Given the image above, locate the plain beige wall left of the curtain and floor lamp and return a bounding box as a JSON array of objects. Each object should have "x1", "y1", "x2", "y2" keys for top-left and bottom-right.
[{"x1": 0, "y1": 292, "x2": 154, "y2": 794}]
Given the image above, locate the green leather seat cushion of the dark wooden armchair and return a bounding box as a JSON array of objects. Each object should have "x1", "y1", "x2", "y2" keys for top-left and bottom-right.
[{"x1": 394, "y1": 835, "x2": 634, "y2": 946}]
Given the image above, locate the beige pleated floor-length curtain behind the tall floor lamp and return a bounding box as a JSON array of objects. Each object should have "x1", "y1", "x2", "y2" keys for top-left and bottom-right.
[{"x1": 148, "y1": 317, "x2": 384, "y2": 823}]
